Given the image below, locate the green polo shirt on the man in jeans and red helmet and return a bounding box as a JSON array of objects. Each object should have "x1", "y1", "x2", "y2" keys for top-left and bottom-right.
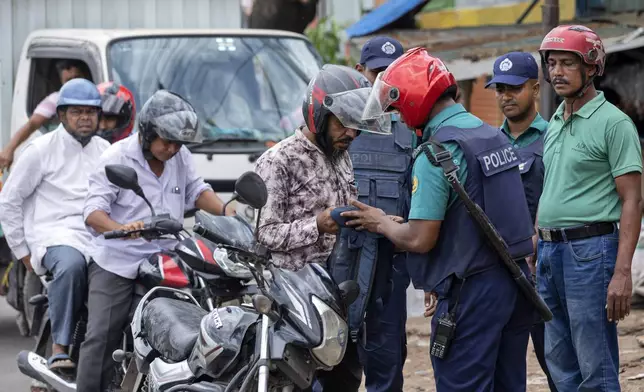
[{"x1": 537, "y1": 91, "x2": 642, "y2": 228}]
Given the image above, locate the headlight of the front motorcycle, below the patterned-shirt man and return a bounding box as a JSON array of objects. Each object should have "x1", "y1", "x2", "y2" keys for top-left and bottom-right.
[{"x1": 311, "y1": 296, "x2": 349, "y2": 366}]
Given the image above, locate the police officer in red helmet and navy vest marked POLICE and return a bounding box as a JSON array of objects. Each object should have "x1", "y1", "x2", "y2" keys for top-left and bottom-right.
[{"x1": 342, "y1": 48, "x2": 534, "y2": 392}]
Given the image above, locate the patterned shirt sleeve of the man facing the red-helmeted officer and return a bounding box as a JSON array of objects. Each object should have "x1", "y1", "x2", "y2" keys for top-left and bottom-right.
[{"x1": 255, "y1": 157, "x2": 320, "y2": 252}]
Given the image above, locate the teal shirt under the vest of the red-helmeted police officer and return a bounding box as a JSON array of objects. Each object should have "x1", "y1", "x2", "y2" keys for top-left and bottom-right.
[{"x1": 409, "y1": 104, "x2": 483, "y2": 220}]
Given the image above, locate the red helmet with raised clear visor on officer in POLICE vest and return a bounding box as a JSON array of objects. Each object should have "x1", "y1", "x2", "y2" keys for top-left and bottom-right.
[{"x1": 363, "y1": 48, "x2": 456, "y2": 128}]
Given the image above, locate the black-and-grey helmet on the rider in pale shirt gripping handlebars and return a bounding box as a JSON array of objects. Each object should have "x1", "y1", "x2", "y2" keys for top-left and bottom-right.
[{"x1": 139, "y1": 90, "x2": 203, "y2": 155}]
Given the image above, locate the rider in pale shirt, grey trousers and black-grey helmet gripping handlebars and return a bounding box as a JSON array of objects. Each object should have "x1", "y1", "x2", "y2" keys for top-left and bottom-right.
[{"x1": 76, "y1": 90, "x2": 235, "y2": 392}]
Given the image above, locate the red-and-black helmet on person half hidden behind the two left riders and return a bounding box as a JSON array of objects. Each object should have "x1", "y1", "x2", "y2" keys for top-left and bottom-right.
[{"x1": 97, "y1": 82, "x2": 136, "y2": 143}]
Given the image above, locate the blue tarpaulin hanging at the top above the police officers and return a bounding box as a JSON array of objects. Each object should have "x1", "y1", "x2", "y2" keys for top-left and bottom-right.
[{"x1": 346, "y1": 0, "x2": 429, "y2": 38}]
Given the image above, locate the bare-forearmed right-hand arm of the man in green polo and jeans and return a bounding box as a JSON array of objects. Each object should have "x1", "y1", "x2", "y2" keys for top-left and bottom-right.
[{"x1": 606, "y1": 121, "x2": 642, "y2": 321}]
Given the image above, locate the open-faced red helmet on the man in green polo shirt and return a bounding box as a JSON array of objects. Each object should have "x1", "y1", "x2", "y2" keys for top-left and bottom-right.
[{"x1": 539, "y1": 25, "x2": 606, "y2": 82}]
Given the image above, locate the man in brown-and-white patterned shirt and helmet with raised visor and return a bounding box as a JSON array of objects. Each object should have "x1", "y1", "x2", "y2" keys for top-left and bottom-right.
[{"x1": 255, "y1": 65, "x2": 391, "y2": 392}]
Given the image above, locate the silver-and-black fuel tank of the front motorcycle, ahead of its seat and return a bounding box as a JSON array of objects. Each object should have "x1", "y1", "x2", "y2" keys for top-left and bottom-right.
[{"x1": 188, "y1": 306, "x2": 260, "y2": 379}]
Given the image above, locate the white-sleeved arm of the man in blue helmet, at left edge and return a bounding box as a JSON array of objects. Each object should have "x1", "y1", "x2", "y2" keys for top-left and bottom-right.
[{"x1": 0, "y1": 145, "x2": 43, "y2": 259}]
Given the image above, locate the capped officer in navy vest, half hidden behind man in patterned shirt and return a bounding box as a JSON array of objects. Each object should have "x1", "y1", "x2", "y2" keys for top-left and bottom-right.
[{"x1": 349, "y1": 37, "x2": 414, "y2": 392}]
